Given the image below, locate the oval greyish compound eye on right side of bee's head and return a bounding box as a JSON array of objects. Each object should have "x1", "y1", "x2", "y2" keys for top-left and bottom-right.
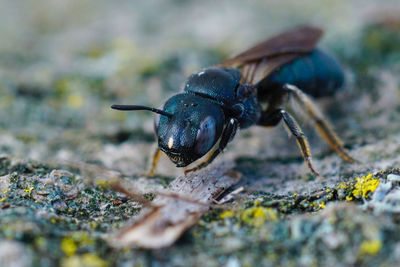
[{"x1": 194, "y1": 116, "x2": 216, "y2": 155}]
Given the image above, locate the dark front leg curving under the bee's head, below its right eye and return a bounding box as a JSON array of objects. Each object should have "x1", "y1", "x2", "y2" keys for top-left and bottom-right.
[{"x1": 185, "y1": 118, "x2": 239, "y2": 175}]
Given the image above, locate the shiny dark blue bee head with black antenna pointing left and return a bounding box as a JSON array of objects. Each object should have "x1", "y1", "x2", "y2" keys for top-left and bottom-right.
[{"x1": 112, "y1": 94, "x2": 225, "y2": 167}]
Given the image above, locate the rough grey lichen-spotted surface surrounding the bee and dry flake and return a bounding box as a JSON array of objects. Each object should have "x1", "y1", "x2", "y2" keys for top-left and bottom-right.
[{"x1": 0, "y1": 0, "x2": 400, "y2": 267}]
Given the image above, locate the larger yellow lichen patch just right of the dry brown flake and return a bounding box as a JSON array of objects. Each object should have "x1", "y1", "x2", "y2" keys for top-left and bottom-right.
[{"x1": 240, "y1": 207, "x2": 278, "y2": 227}]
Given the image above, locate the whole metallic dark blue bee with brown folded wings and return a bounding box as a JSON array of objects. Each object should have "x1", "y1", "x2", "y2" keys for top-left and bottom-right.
[{"x1": 112, "y1": 26, "x2": 354, "y2": 176}]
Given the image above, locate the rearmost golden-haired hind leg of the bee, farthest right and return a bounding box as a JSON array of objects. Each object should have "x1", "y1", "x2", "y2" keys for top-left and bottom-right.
[{"x1": 284, "y1": 84, "x2": 356, "y2": 162}]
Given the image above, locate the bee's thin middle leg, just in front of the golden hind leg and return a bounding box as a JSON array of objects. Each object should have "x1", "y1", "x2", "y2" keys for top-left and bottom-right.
[{"x1": 279, "y1": 109, "x2": 320, "y2": 177}]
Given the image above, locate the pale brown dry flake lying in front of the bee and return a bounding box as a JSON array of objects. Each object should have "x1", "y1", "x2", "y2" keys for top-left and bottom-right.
[{"x1": 110, "y1": 162, "x2": 241, "y2": 249}]
